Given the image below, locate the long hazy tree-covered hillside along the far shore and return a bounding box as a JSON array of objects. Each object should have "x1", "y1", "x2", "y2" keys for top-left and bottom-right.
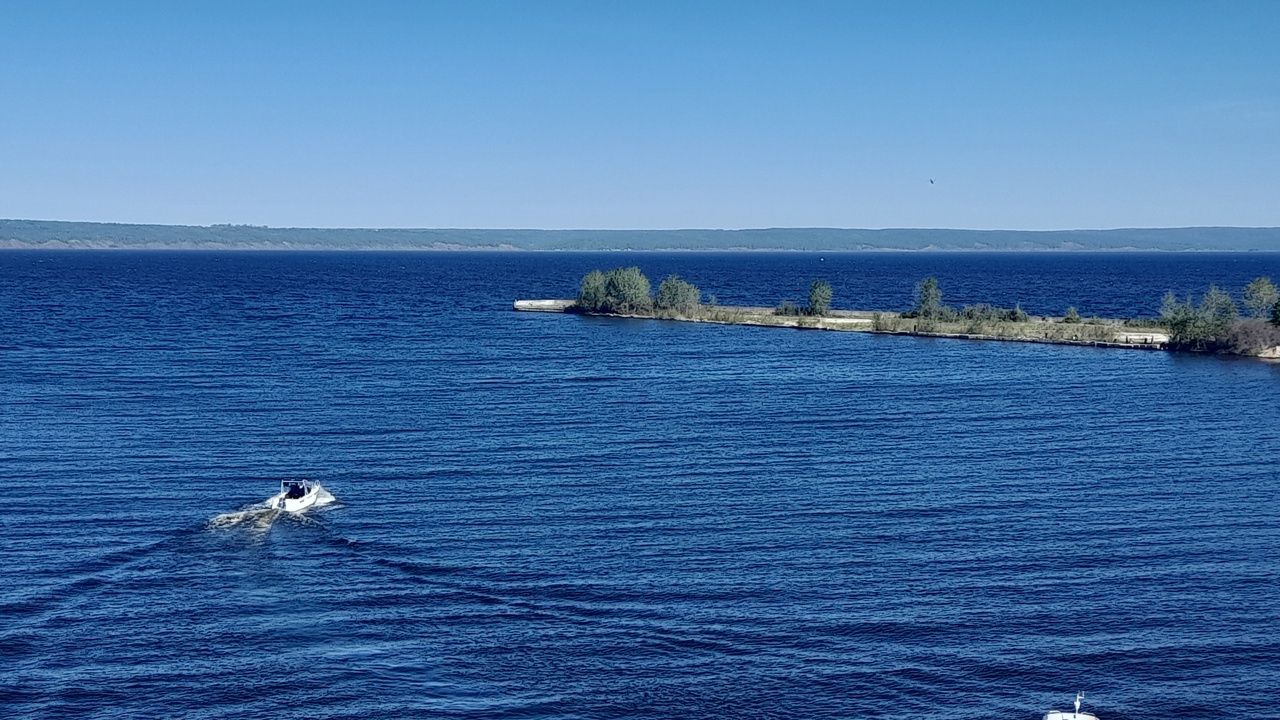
[{"x1": 0, "y1": 220, "x2": 1280, "y2": 252}]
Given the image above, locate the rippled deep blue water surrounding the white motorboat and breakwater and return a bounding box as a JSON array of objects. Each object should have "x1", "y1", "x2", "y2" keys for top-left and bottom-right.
[{"x1": 0, "y1": 251, "x2": 1280, "y2": 720}]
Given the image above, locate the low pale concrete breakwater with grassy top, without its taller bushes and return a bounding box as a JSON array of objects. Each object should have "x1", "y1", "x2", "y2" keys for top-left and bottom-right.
[{"x1": 515, "y1": 300, "x2": 1169, "y2": 350}]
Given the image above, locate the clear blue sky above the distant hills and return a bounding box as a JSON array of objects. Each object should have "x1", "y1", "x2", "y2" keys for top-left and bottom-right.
[{"x1": 0, "y1": 0, "x2": 1280, "y2": 229}]
